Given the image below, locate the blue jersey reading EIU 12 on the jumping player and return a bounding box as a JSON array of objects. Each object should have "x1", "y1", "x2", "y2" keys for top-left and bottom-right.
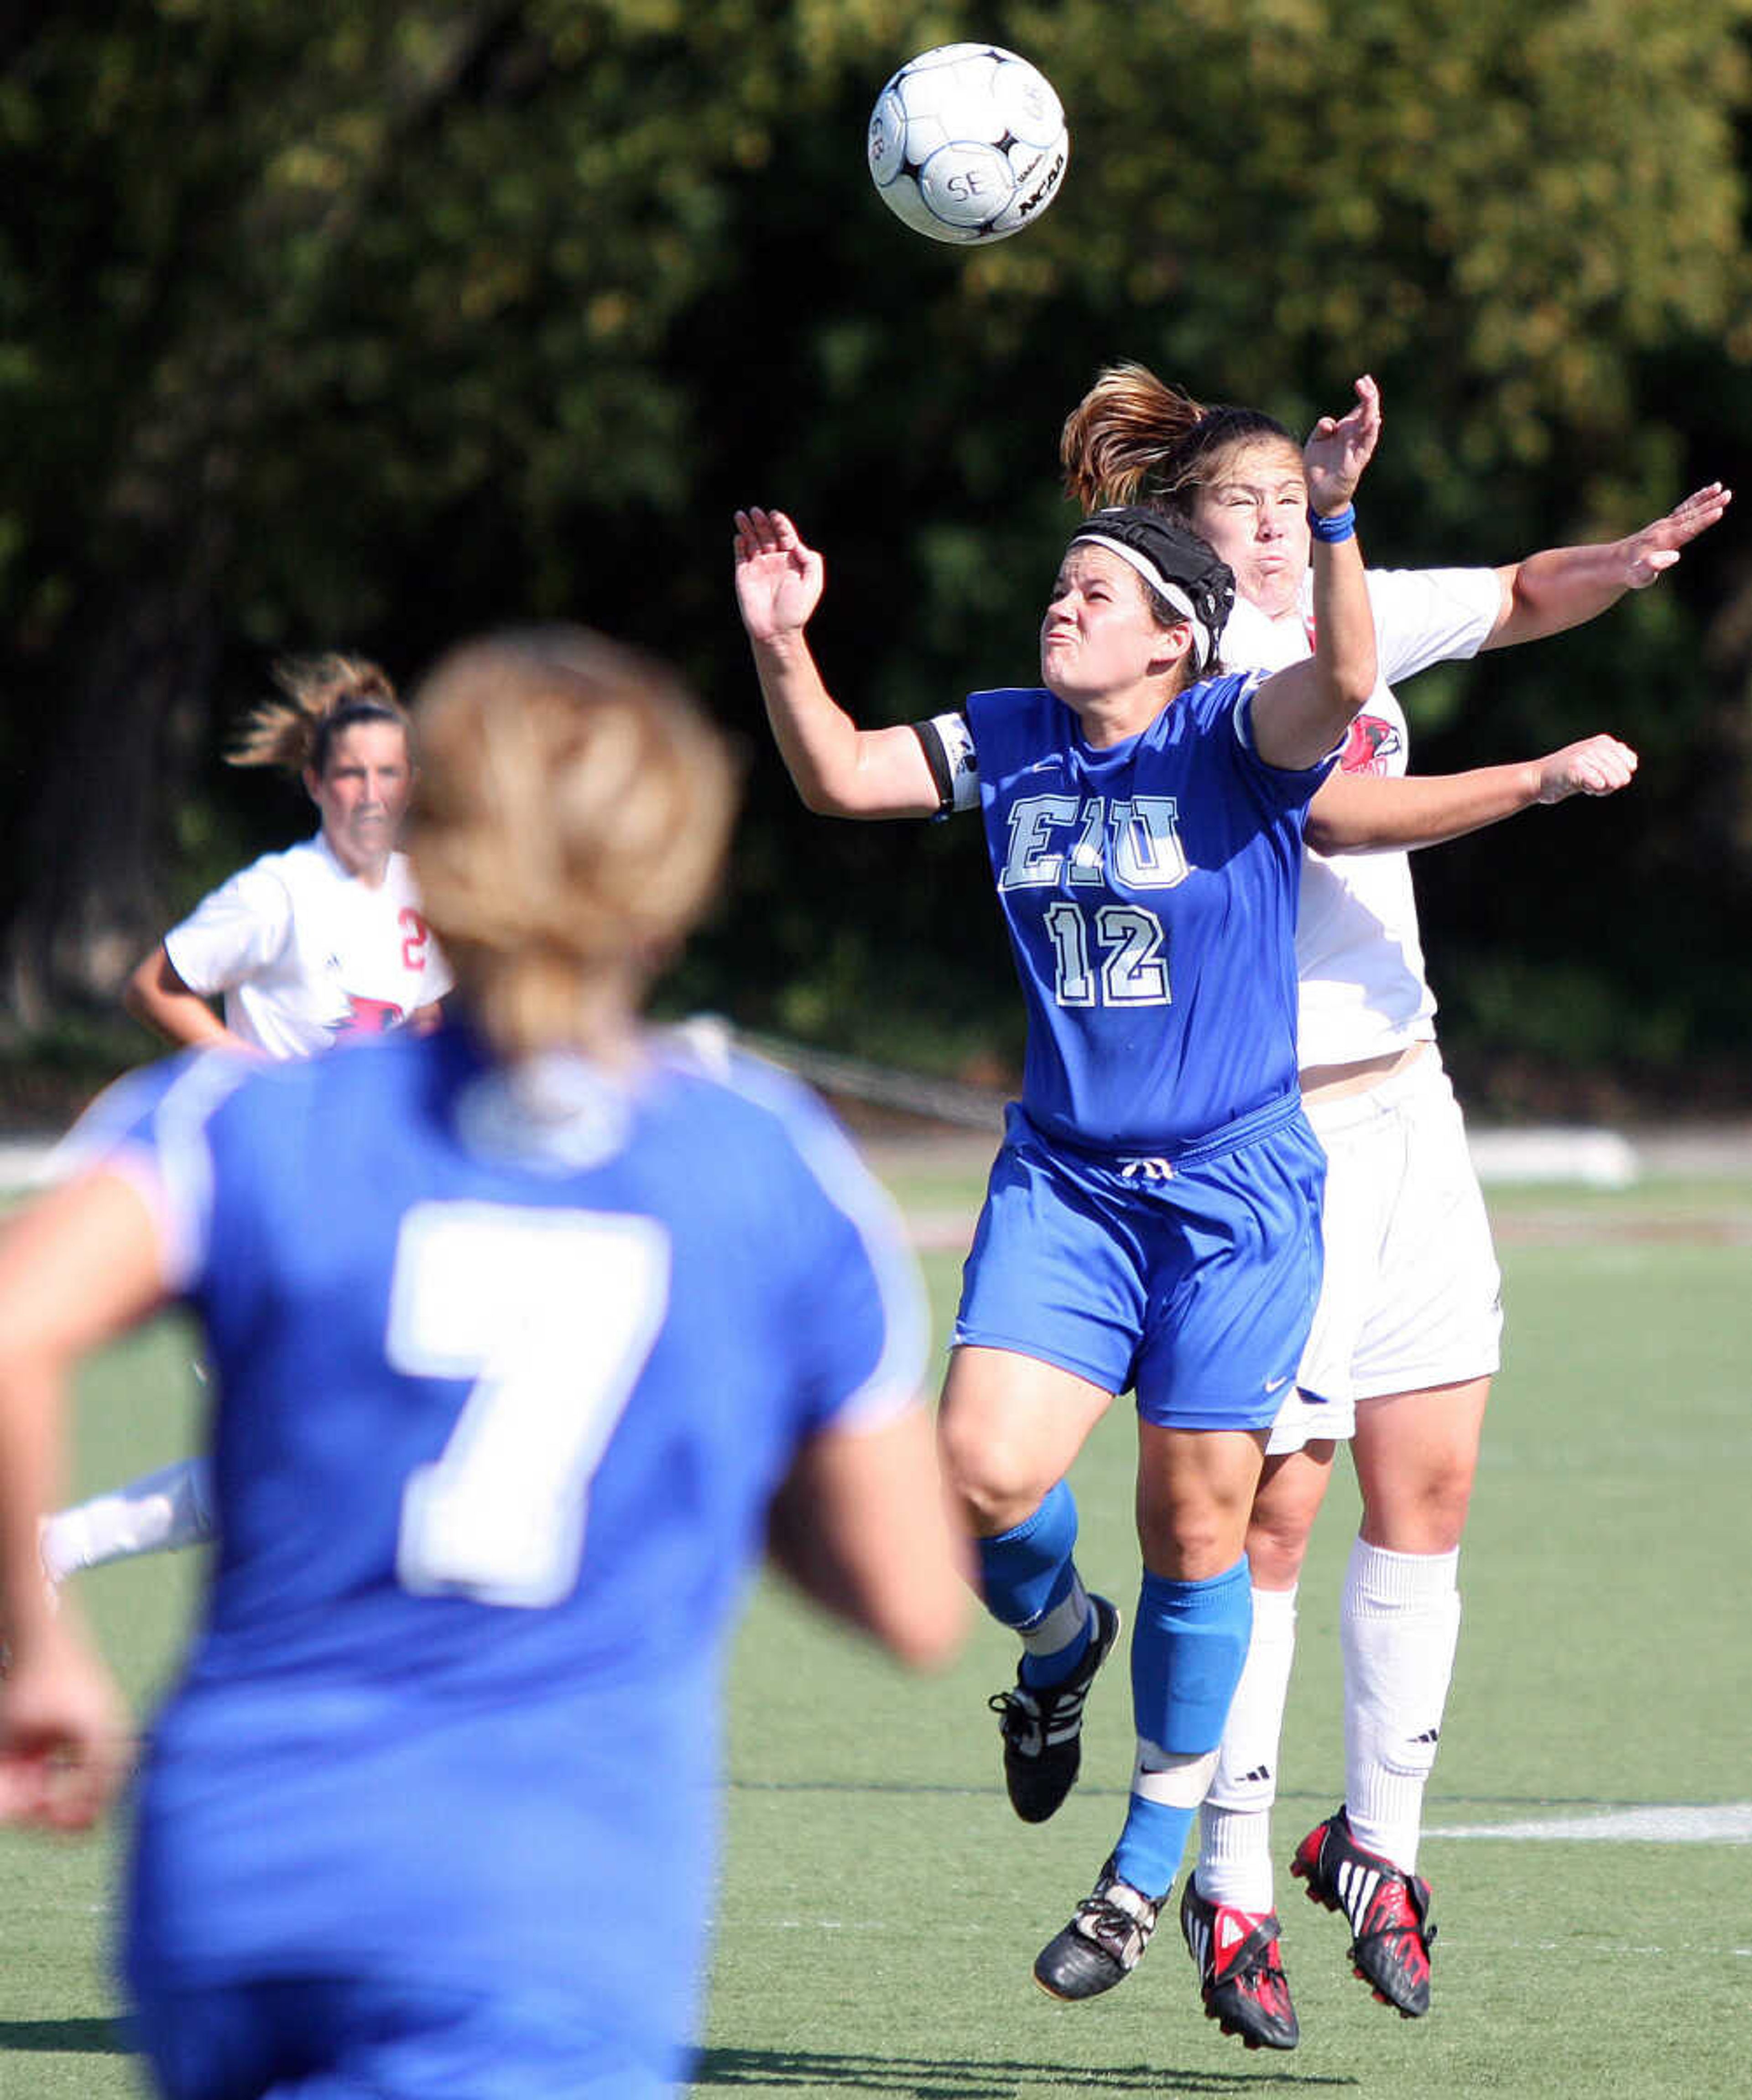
[{"x1": 958, "y1": 674, "x2": 1330, "y2": 1155}]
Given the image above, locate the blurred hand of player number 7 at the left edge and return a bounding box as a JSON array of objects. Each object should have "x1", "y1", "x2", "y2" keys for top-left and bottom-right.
[{"x1": 0, "y1": 1621, "x2": 132, "y2": 1831}]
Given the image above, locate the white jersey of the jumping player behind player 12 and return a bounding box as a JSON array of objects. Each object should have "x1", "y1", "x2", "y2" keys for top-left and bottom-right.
[{"x1": 1223, "y1": 569, "x2": 1502, "y2": 1071}]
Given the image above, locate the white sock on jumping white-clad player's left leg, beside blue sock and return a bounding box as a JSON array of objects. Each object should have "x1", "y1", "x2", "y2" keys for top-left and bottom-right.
[{"x1": 1197, "y1": 1588, "x2": 1296, "y2": 1911}]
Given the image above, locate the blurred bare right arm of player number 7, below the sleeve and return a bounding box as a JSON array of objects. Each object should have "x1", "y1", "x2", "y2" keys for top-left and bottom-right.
[{"x1": 767, "y1": 1407, "x2": 973, "y2": 1669}]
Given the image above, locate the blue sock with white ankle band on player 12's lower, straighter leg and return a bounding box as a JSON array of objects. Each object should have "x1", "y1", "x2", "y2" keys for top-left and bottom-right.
[{"x1": 1116, "y1": 1556, "x2": 1252, "y2": 1897}]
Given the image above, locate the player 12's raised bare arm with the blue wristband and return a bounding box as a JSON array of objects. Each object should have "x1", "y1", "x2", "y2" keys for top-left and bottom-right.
[{"x1": 1252, "y1": 376, "x2": 1380, "y2": 771}]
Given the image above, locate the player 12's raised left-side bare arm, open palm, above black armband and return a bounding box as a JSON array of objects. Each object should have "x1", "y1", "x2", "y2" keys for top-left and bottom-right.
[{"x1": 735, "y1": 508, "x2": 939, "y2": 817}]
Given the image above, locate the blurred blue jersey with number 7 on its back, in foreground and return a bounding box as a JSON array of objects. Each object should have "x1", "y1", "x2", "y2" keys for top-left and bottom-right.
[{"x1": 85, "y1": 1029, "x2": 924, "y2": 2074}]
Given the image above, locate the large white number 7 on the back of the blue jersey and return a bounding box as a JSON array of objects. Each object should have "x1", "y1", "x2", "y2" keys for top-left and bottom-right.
[{"x1": 385, "y1": 1204, "x2": 670, "y2": 1606}]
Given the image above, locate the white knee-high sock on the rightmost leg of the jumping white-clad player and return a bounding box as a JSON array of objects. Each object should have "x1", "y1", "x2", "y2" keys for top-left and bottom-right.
[{"x1": 1338, "y1": 1539, "x2": 1460, "y2": 1873}]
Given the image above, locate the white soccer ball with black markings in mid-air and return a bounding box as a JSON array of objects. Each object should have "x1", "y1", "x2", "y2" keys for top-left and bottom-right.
[{"x1": 870, "y1": 44, "x2": 1071, "y2": 241}]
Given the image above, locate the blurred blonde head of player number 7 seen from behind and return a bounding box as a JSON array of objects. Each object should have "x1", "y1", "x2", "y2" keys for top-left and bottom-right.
[{"x1": 407, "y1": 628, "x2": 737, "y2": 1056}]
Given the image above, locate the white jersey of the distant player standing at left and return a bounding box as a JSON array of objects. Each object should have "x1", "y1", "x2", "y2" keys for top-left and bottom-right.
[{"x1": 164, "y1": 832, "x2": 452, "y2": 1058}]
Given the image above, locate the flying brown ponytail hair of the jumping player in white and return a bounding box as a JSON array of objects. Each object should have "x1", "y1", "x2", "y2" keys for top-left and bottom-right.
[{"x1": 1059, "y1": 363, "x2": 1300, "y2": 516}]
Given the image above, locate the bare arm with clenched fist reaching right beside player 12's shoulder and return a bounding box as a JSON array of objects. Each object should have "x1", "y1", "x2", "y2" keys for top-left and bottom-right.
[{"x1": 1307, "y1": 735, "x2": 1637, "y2": 853}]
